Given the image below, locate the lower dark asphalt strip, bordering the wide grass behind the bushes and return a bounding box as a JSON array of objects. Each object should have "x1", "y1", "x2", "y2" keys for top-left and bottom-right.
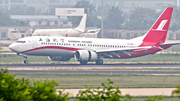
[{"x1": 3, "y1": 70, "x2": 180, "y2": 74}]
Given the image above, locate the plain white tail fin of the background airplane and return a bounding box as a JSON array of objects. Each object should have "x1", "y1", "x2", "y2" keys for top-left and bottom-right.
[{"x1": 75, "y1": 14, "x2": 87, "y2": 32}]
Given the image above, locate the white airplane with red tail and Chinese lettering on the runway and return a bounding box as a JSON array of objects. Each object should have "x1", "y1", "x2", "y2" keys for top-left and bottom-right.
[{"x1": 9, "y1": 7, "x2": 180, "y2": 65}]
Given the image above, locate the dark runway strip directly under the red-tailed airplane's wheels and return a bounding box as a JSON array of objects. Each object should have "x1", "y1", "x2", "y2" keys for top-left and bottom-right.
[{"x1": 0, "y1": 64, "x2": 180, "y2": 68}]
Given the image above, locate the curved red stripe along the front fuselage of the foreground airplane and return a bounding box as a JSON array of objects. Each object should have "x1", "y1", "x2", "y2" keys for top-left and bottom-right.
[{"x1": 21, "y1": 46, "x2": 80, "y2": 53}]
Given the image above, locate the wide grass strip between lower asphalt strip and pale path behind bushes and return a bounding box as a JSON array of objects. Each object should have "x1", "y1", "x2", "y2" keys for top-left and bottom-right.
[{"x1": 16, "y1": 74, "x2": 180, "y2": 89}]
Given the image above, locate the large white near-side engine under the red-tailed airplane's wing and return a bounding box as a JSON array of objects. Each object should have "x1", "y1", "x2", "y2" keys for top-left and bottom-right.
[{"x1": 74, "y1": 50, "x2": 98, "y2": 61}]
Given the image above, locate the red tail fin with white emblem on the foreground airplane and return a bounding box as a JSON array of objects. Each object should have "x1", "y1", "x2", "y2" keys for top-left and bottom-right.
[{"x1": 140, "y1": 7, "x2": 173, "y2": 46}]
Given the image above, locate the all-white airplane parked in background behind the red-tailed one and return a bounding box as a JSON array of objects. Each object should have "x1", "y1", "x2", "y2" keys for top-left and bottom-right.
[{"x1": 32, "y1": 14, "x2": 99, "y2": 37}]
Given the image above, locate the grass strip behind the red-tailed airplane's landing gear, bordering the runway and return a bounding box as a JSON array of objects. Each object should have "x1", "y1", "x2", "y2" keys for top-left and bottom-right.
[{"x1": 1, "y1": 54, "x2": 180, "y2": 64}]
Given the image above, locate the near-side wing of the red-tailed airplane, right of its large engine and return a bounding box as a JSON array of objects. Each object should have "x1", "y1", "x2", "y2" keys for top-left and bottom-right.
[{"x1": 96, "y1": 46, "x2": 155, "y2": 58}]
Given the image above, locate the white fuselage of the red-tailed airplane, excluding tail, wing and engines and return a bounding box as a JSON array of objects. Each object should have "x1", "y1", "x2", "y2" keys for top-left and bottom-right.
[{"x1": 10, "y1": 36, "x2": 142, "y2": 57}]
